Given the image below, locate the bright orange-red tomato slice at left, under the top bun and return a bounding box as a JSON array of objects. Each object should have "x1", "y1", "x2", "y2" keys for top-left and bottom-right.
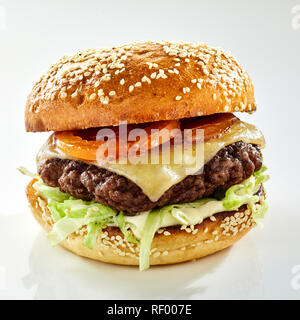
[{"x1": 54, "y1": 120, "x2": 180, "y2": 161}]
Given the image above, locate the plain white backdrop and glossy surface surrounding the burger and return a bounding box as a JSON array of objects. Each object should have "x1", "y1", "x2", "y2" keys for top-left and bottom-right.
[{"x1": 0, "y1": 0, "x2": 300, "y2": 299}]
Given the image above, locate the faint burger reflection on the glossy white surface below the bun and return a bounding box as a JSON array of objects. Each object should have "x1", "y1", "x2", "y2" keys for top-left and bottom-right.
[{"x1": 23, "y1": 233, "x2": 230, "y2": 299}]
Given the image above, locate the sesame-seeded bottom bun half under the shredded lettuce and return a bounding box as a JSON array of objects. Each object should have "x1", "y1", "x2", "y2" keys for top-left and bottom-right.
[{"x1": 26, "y1": 180, "x2": 255, "y2": 265}]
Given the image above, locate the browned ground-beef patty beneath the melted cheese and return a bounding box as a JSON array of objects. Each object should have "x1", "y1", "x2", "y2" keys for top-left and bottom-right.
[{"x1": 39, "y1": 141, "x2": 262, "y2": 214}]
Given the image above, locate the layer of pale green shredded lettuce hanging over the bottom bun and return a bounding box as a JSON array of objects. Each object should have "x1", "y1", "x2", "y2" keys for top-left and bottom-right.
[{"x1": 19, "y1": 166, "x2": 269, "y2": 271}]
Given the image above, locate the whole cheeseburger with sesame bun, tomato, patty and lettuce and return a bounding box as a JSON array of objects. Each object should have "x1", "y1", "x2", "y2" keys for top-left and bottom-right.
[{"x1": 20, "y1": 41, "x2": 268, "y2": 270}]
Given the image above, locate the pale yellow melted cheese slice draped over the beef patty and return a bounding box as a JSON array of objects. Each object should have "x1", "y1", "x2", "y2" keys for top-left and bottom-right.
[{"x1": 37, "y1": 121, "x2": 265, "y2": 202}]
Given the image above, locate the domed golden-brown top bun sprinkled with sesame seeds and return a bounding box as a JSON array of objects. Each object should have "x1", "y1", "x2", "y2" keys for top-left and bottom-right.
[{"x1": 25, "y1": 41, "x2": 256, "y2": 131}]
